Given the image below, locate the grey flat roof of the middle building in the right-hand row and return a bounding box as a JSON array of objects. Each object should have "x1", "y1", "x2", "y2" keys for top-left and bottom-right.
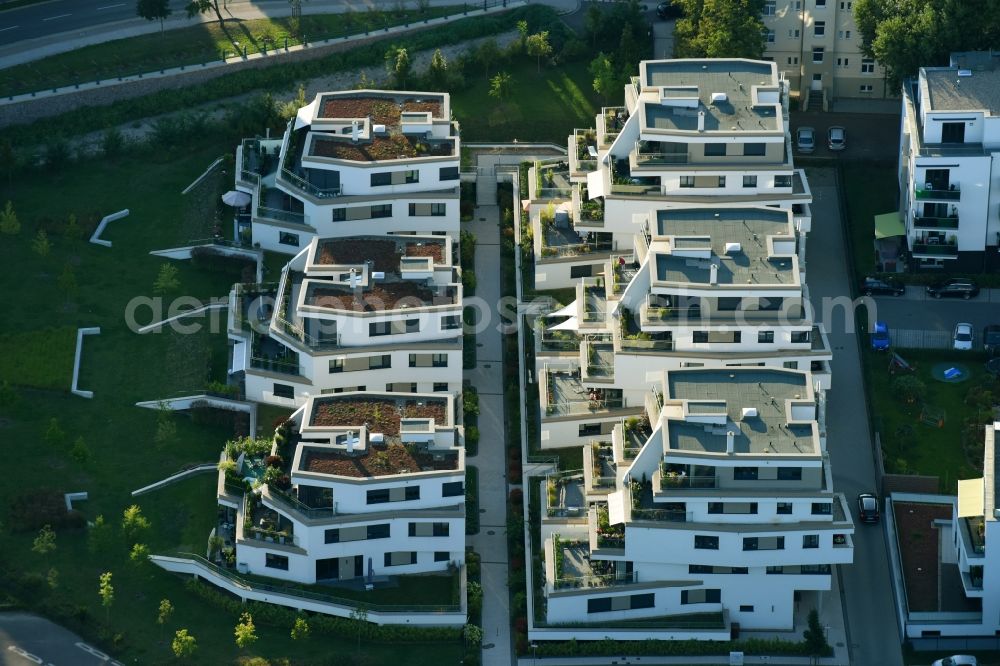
[{"x1": 650, "y1": 208, "x2": 799, "y2": 285}]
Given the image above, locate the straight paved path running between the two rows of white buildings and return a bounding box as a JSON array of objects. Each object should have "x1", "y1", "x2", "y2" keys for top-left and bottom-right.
[{"x1": 462, "y1": 167, "x2": 513, "y2": 666}]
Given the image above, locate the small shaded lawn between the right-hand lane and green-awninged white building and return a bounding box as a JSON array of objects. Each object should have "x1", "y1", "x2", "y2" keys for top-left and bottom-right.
[{"x1": 840, "y1": 162, "x2": 899, "y2": 279}]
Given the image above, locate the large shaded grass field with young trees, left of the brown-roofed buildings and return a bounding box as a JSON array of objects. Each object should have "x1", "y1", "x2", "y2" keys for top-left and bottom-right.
[{"x1": 0, "y1": 141, "x2": 462, "y2": 665}]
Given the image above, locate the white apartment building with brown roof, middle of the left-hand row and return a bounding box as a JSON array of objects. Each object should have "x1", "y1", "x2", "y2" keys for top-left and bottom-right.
[{"x1": 229, "y1": 235, "x2": 462, "y2": 407}]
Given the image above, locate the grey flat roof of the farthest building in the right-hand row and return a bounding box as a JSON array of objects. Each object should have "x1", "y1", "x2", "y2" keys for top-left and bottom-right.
[{"x1": 640, "y1": 59, "x2": 781, "y2": 133}]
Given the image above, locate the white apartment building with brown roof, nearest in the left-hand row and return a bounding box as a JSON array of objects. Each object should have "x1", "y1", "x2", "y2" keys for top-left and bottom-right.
[{"x1": 218, "y1": 392, "x2": 465, "y2": 584}]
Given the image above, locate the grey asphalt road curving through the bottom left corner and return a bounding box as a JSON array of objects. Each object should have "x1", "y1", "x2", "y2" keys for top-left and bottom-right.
[{"x1": 0, "y1": 613, "x2": 121, "y2": 666}]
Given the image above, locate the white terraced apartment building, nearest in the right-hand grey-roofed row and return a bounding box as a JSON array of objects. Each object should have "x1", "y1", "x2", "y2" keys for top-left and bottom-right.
[{"x1": 529, "y1": 367, "x2": 854, "y2": 640}]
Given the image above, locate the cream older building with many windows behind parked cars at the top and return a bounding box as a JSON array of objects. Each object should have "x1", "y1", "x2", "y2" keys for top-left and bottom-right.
[{"x1": 761, "y1": 0, "x2": 899, "y2": 111}]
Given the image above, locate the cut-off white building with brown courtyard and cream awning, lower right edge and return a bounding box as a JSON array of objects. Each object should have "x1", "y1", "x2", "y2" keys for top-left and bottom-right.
[{"x1": 885, "y1": 421, "x2": 1000, "y2": 636}]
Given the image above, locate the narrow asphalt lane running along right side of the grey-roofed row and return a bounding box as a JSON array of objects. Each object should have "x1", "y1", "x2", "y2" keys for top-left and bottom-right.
[{"x1": 806, "y1": 169, "x2": 903, "y2": 666}]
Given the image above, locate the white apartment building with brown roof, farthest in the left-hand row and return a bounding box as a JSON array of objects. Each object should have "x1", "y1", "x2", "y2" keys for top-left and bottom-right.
[{"x1": 236, "y1": 90, "x2": 460, "y2": 255}]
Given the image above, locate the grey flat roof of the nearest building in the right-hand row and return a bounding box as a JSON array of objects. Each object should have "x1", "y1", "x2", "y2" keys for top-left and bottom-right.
[{"x1": 665, "y1": 368, "x2": 820, "y2": 455}]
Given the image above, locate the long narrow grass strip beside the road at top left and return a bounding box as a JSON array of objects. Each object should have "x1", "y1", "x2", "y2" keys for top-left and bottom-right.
[{"x1": 0, "y1": 7, "x2": 461, "y2": 97}]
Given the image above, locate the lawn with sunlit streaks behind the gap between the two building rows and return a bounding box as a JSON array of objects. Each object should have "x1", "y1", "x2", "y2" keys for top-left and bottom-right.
[{"x1": 451, "y1": 59, "x2": 601, "y2": 146}]
